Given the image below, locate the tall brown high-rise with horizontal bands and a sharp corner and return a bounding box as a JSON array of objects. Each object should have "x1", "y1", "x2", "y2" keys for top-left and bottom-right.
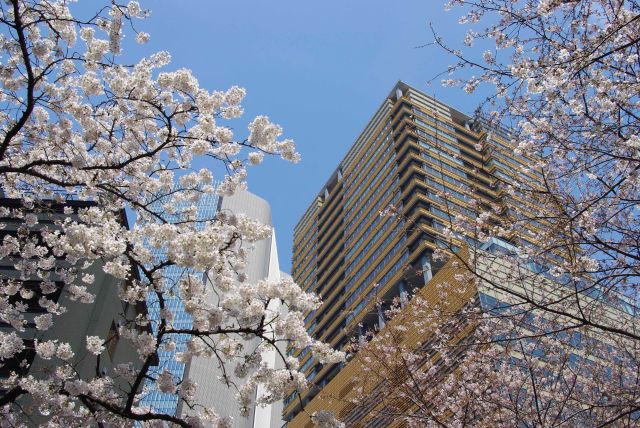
[{"x1": 284, "y1": 82, "x2": 536, "y2": 426}]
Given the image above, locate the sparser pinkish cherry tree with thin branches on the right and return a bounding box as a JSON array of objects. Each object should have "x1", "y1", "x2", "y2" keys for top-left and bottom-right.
[{"x1": 312, "y1": 0, "x2": 640, "y2": 427}]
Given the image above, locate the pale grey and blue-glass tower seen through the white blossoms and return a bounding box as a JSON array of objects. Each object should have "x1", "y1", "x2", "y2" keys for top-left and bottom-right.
[{"x1": 141, "y1": 190, "x2": 281, "y2": 428}]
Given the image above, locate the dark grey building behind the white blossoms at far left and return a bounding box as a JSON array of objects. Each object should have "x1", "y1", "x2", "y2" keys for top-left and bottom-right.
[{"x1": 0, "y1": 198, "x2": 154, "y2": 426}]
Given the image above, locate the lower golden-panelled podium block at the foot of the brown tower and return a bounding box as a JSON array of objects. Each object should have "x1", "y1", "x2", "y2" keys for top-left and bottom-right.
[{"x1": 287, "y1": 239, "x2": 640, "y2": 428}]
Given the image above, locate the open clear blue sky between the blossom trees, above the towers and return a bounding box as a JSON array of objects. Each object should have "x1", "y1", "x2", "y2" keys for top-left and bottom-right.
[{"x1": 109, "y1": 0, "x2": 479, "y2": 271}]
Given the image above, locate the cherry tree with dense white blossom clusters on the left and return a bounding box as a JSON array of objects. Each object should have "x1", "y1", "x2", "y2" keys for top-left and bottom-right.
[{"x1": 0, "y1": 0, "x2": 342, "y2": 426}]
